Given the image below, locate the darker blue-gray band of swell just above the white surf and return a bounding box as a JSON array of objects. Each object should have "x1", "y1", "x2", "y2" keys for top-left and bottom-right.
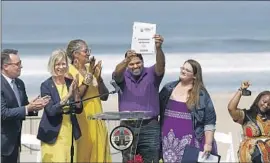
[{"x1": 2, "y1": 36, "x2": 270, "y2": 55}]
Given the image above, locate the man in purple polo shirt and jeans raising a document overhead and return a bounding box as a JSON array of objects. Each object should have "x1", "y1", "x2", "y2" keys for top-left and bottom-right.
[{"x1": 113, "y1": 22, "x2": 165, "y2": 162}]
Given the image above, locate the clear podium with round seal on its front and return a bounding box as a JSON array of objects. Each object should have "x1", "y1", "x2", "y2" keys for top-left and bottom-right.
[{"x1": 88, "y1": 111, "x2": 151, "y2": 162}]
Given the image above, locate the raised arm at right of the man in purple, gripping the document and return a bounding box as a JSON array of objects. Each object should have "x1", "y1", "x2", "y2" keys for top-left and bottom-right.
[{"x1": 154, "y1": 35, "x2": 165, "y2": 76}]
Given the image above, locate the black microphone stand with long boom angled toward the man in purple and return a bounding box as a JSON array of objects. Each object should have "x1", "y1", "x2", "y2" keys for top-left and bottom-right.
[{"x1": 62, "y1": 91, "x2": 118, "y2": 163}]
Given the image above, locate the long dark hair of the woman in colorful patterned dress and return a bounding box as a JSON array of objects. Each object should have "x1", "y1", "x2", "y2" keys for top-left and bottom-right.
[{"x1": 247, "y1": 91, "x2": 270, "y2": 119}]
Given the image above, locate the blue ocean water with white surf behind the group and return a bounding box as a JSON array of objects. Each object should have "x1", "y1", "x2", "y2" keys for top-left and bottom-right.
[{"x1": 2, "y1": 1, "x2": 270, "y2": 96}]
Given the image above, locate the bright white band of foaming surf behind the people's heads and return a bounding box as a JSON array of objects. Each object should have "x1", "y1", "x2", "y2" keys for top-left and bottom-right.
[{"x1": 22, "y1": 52, "x2": 270, "y2": 75}]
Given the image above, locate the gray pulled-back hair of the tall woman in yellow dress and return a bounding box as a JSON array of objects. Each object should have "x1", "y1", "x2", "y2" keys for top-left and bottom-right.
[{"x1": 66, "y1": 39, "x2": 87, "y2": 64}]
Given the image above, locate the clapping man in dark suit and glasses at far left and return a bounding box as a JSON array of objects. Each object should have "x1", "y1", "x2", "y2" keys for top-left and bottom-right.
[{"x1": 1, "y1": 49, "x2": 50, "y2": 163}]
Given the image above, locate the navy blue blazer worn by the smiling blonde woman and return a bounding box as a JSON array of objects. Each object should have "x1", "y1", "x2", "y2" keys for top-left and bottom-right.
[{"x1": 37, "y1": 77, "x2": 83, "y2": 144}]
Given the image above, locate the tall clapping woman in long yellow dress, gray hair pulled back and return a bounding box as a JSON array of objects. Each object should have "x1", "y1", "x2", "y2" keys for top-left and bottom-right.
[{"x1": 66, "y1": 39, "x2": 111, "y2": 162}]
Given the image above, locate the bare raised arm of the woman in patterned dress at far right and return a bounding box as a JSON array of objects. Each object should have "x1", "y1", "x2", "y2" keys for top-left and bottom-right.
[{"x1": 228, "y1": 81, "x2": 250, "y2": 124}]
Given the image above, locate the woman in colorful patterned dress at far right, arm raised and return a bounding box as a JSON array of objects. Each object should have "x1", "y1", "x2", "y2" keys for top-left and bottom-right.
[{"x1": 228, "y1": 82, "x2": 270, "y2": 163}]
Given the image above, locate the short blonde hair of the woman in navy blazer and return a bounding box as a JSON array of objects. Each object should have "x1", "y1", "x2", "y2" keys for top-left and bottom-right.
[{"x1": 48, "y1": 49, "x2": 68, "y2": 76}]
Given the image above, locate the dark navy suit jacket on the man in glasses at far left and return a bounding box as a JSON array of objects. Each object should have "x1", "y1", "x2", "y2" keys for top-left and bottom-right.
[{"x1": 1, "y1": 74, "x2": 37, "y2": 156}]
